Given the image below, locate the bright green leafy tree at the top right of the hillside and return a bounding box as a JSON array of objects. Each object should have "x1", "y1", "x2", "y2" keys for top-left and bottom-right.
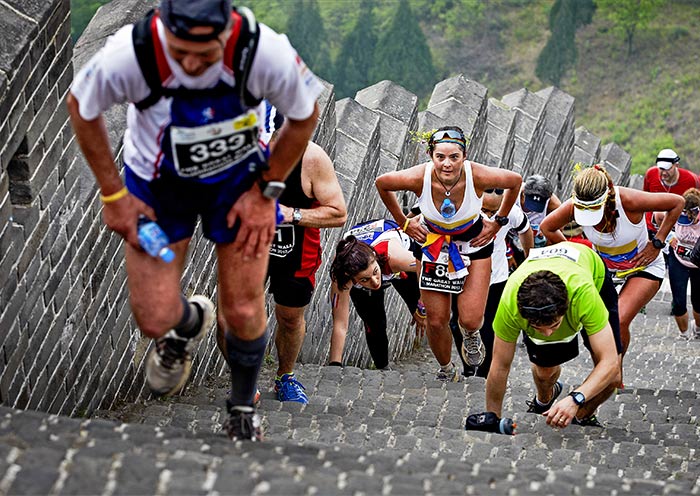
[{"x1": 596, "y1": 0, "x2": 663, "y2": 57}]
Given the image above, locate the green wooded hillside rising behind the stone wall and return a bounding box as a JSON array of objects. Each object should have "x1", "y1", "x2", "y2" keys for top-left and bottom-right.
[{"x1": 71, "y1": 0, "x2": 700, "y2": 173}]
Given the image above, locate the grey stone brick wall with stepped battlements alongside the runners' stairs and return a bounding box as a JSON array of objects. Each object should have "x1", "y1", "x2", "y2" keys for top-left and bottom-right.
[{"x1": 0, "y1": 0, "x2": 638, "y2": 415}]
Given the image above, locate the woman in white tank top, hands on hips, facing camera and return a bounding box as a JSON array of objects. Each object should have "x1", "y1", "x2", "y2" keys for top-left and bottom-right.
[{"x1": 375, "y1": 126, "x2": 522, "y2": 380}]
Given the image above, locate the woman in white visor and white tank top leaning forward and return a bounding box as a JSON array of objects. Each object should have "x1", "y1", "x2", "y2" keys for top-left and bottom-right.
[{"x1": 540, "y1": 165, "x2": 684, "y2": 362}]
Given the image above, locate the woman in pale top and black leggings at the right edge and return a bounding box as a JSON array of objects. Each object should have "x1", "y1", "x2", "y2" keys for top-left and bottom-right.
[{"x1": 654, "y1": 188, "x2": 700, "y2": 339}]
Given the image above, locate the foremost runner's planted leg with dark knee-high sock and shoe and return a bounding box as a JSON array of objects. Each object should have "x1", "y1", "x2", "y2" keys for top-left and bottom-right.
[{"x1": 216, "y1": 243, "x2": 268, "y2": 440}]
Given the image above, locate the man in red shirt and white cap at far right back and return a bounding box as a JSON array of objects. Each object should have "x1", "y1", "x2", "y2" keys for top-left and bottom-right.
[{"x1": 642, "y1": 148, "x2": 700, "y2": 236}]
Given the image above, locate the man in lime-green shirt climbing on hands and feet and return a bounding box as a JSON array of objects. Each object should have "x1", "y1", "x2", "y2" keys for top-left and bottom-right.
[{"x1": 486, "y1": 242, "x2": 622, "y2": 428}]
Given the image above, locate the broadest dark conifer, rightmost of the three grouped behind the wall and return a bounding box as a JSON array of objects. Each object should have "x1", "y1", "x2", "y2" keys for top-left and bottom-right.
[{"x1": 370, "y1": 0, "x2": 436, "y2": 97}]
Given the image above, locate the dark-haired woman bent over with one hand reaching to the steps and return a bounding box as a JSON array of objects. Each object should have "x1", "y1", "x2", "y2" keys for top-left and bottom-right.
[{"x1": 329, "y1": 219, "x2": 425, "y2": 369}]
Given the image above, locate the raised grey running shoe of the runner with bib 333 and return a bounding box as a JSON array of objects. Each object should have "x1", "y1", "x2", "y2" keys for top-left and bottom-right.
[{"x1": 146, "y1": 295, "x2": 214, "y2": 396}]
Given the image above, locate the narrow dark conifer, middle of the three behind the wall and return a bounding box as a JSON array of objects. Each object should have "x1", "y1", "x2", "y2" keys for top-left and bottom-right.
[{"x1": 333, "y1": 0, "x2": 377, "y2": 99}]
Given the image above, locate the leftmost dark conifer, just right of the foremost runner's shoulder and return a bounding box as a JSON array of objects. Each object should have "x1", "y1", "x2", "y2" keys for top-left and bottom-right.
[{"x1": 286, "y1": 0, "x2": 333, "y2": 79}]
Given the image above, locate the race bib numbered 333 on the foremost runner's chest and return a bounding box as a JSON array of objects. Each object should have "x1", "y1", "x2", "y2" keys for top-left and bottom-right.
[{"x1": 170, "y1": 110, "x2": 258, "y2": 177}]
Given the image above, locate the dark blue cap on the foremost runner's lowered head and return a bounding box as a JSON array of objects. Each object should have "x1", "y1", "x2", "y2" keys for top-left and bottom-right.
[{"x1": 158, "y1": 0, "x2": 231, "y2": 41}]
